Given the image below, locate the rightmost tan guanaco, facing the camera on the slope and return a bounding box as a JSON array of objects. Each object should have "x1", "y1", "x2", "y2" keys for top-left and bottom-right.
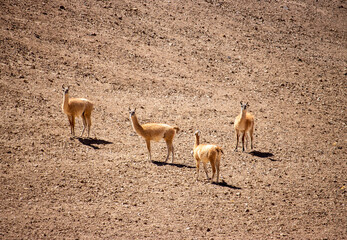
[{"x1": 234, "y1": 102, "x2": 254, "y2": 151}]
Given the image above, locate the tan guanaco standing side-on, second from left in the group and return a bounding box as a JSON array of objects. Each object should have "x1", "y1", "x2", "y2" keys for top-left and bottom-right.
[{"x1": 129, "y1": 108, "x2": 179, "y2": 162}]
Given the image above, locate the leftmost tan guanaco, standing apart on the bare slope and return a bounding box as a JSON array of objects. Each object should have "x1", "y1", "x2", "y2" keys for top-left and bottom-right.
[{"x1": 62, "y1": 85, "x2": 93, "y2": 137}]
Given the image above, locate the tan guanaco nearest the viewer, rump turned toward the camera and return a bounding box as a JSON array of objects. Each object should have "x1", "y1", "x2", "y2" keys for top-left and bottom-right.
[{"x1": 193, "y1": 130, "x2": 223, "y2": 182}]
